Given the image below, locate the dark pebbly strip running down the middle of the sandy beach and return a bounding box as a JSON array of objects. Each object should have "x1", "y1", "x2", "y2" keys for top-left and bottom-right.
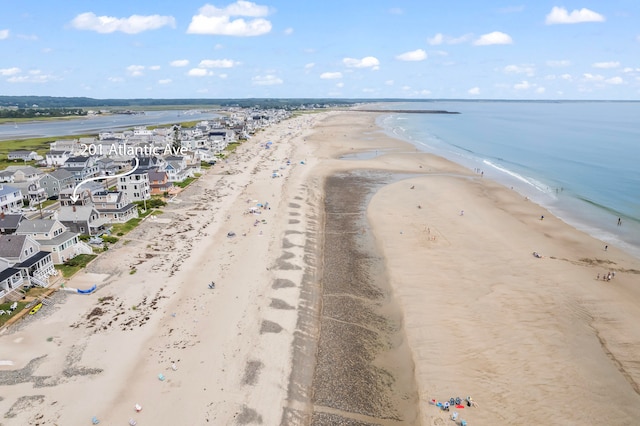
[{"x1": 310, "y1": 172, "x2": 419, "y2": 425}]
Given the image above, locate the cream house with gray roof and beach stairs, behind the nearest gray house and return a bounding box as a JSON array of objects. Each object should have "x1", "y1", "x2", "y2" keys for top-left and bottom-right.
[{"x1": 16, "y1": 219, "x2": 93, "y2": 265}]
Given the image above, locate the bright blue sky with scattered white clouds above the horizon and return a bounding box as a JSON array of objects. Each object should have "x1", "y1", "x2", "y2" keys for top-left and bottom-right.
[{"x1": 0, "y1": 0, "x2": 640, "y2": 100}]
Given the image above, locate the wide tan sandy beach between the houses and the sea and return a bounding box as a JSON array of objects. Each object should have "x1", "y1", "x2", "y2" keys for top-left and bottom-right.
[{"x1": 0, "y1": 111, "x2": 640, "y2": 426}]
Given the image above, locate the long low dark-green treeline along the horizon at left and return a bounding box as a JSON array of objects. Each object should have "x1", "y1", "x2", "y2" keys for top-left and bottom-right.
[{"x1": 0, "y1": 96, "x2": 364, "y2": 109}]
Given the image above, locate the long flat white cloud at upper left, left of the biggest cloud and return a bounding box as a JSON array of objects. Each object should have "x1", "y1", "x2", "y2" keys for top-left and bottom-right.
[{"x1": 71, "y1": 12, "x2": 176, "y2": 34}]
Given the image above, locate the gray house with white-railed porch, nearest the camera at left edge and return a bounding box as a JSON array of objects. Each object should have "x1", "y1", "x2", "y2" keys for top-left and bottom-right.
[{"x1": 0, "y1": 235, "x2": 58, "y2": 287}]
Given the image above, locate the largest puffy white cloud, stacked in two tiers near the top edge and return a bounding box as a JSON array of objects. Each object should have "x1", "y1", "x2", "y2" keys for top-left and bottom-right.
[{"x1": 187, "y1": 0, "x2": 271, "y2": 37}]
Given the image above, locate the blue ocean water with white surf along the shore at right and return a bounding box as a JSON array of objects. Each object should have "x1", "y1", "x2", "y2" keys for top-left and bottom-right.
[{"x1": 379, "y1": 101, "x2": 640, "y2": 258}]
